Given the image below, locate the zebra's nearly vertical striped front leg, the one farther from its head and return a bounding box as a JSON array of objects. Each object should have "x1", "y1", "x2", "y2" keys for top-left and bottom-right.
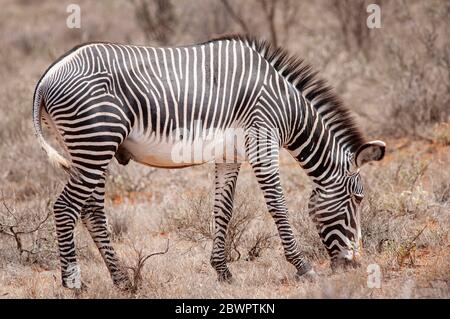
[{"x1": 211, "y1": 163, "x2": 241, "y2": 282}]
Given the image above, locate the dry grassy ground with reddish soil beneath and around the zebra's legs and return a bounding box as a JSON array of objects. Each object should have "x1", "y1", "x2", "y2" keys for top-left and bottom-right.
[{"x1": 0, "y1": 141, "x2": 450, "y2": 298}]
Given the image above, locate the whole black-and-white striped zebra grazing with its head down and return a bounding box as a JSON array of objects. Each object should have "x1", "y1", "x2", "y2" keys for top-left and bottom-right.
[{"x1": 33, "y1": 36, "x2": 385, "y2": 288}]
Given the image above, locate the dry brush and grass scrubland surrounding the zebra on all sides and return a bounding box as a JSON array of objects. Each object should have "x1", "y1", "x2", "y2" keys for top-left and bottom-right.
[{"x1": 0, "y1": 0, "x2": 450, "y2": 298}]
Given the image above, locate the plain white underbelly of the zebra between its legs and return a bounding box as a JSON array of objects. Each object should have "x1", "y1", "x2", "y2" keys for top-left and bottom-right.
[{"x1": 122, "y1": 134, "x2": 245, "y2": 168}]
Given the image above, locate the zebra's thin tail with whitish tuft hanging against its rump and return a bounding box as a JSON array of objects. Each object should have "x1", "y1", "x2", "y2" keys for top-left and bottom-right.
[{"x1": 33, "y1": 83, "x2": 72, "y2": 173}]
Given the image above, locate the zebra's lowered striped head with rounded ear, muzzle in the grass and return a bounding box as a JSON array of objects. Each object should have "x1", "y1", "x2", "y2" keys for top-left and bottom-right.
[{"x1": 308, "y1": 141, "x2": 385, "y2": 270}]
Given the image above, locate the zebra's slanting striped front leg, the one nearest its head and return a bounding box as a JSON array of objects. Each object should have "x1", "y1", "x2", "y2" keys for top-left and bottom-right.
[{"x1": 246, "y1": 132, "x2": 316, "y2": 279}]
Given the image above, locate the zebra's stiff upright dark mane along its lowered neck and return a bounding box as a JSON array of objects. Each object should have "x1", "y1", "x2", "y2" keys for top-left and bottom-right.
[{"x1": 207, "y1": 35, "x2": 365, "y2": 151}]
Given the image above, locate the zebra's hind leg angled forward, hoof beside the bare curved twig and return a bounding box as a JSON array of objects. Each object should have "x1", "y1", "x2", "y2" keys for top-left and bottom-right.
[{"x1": 81, "y1": 177, "x2": 131, "y2": 290}]
